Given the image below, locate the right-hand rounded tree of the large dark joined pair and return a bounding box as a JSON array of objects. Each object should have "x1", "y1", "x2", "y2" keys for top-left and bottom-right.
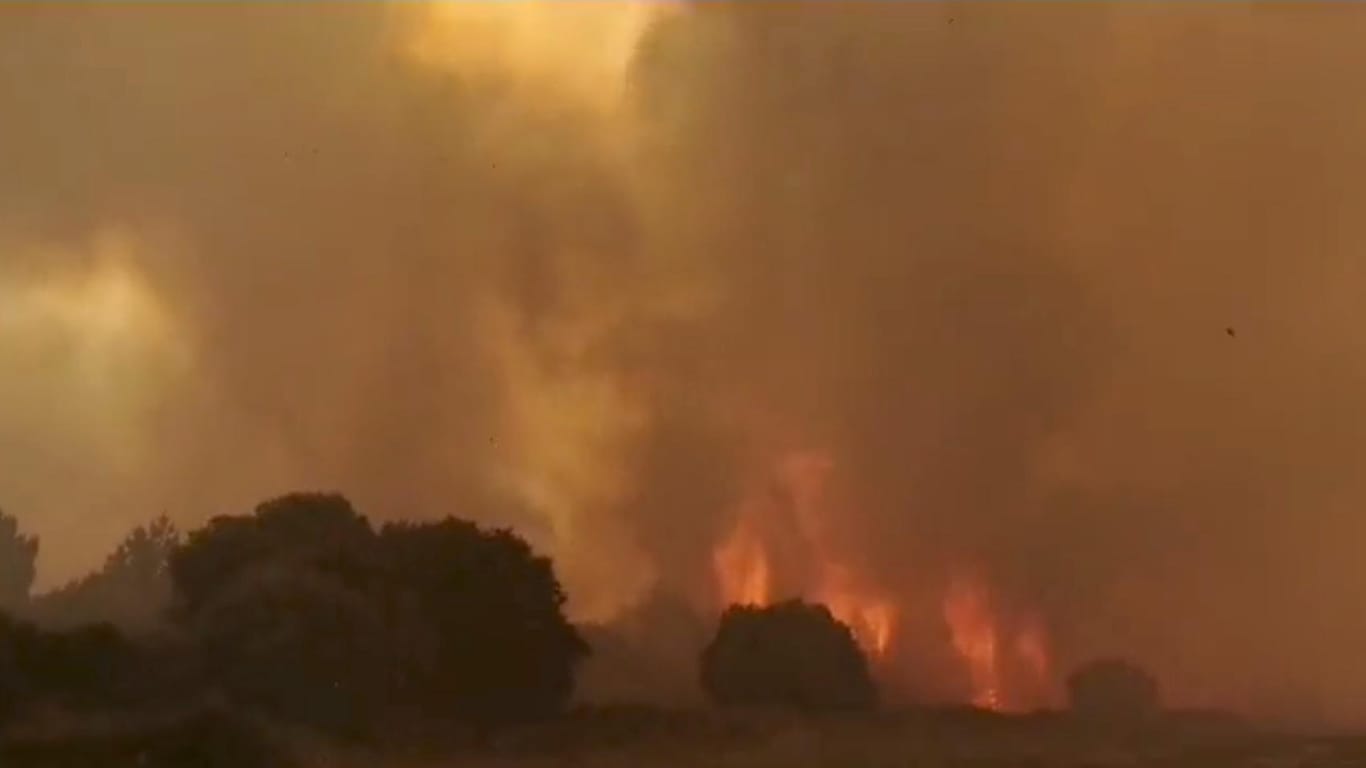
[{"x1": 380, "y1": 518, "x2": 587, "y2": 726}]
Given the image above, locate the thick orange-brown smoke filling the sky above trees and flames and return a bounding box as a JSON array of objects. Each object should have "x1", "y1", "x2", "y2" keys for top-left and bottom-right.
[{"x1": 0, "y1": 4, "x2": 1366, "y2": 722}]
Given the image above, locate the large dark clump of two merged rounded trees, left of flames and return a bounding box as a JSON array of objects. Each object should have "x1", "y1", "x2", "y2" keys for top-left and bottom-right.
[{"x1": 171, "y1": 493, "x2": 587, "y2": 735}]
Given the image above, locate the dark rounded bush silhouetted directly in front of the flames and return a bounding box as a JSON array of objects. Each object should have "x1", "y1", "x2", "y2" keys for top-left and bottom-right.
[{"x1": 702, "y1": 600, "x2": 877, "y2": 712}]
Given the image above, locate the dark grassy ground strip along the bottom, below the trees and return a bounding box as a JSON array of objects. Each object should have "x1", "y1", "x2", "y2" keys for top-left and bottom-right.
[{"x1": 0, "y1": 711, "x2": 1366, "y2": 768}]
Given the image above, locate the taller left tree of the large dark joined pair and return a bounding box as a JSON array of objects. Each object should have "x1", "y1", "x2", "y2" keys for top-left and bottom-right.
[{"x1": 169, "y1": 493, "x2": 393, "y2": 732}]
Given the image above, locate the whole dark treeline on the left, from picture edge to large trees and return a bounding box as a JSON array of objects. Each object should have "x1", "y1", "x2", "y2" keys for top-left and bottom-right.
[{"x1": 0, "y1": 495, "x2": 587, "y2": 735}]
